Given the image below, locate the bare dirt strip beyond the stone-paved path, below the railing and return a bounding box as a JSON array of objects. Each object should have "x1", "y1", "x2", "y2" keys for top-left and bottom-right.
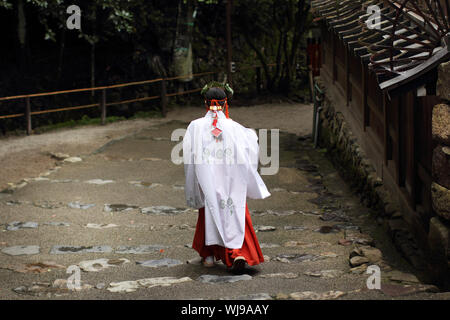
[{"x1": 0, "y1": 104, "x2": 312, "y2": 190}]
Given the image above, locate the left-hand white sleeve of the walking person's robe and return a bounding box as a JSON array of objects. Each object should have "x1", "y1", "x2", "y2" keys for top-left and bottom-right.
[{"x1": 183, "y1": 125, "x2": 205, "y2": 209}]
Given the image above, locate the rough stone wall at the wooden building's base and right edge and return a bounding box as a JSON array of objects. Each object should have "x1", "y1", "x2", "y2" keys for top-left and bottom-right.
[{"x1": 317, "y1": 64, "x2": 450, "y2": 288}]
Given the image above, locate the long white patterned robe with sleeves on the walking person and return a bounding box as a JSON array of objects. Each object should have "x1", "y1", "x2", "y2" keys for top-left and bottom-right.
[{"x1": 183, "y1": 111, "x2": 270, "y2": 249}]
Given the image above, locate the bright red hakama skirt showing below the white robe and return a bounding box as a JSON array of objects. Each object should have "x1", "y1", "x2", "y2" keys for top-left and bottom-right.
[{"x1": 192, "y1": 204, "x2": 264, "y2": 267}]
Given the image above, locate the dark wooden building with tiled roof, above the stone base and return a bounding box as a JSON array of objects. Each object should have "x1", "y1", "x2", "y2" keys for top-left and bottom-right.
[{"x1": 312, "y1": 0, "x2": 450, "y2": 274}]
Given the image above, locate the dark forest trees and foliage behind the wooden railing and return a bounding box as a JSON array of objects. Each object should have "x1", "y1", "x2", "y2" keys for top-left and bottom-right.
[{"x1": 0, "y1": 0, "x2": 311, "y2": 134}]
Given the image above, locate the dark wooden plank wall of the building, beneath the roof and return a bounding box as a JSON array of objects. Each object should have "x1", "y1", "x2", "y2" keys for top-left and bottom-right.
[{"x1": 321, "y1": 15, "x2": 439, "y2": 221}]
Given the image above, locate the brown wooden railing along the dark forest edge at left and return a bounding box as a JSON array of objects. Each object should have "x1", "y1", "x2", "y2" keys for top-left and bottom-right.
[{"x1": 0, "y1": 64, "x2": 276, "y2": 135}]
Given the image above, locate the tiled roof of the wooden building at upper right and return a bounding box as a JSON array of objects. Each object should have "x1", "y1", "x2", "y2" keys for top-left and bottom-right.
[{"x1": 312, "y1": 0, "x2": 450, "y2": 90}]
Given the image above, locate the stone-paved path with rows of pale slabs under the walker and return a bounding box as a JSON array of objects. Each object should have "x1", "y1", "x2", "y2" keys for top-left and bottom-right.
[{"x1": 0, "y1": 110, "x2": 449, "y2": 299}]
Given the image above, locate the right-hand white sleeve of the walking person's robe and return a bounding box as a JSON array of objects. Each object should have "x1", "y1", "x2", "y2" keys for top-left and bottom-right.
[{"x1": 246, "y1": 129, "x2": 270, "y2": 199}]
